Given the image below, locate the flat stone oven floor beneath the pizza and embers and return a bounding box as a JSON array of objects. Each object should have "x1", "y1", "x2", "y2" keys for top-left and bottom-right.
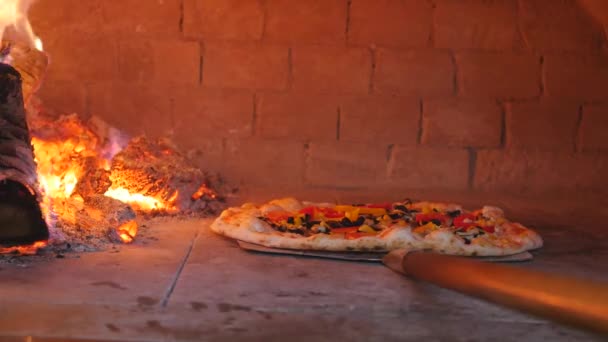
[{"x1": 0, "y1": 219, "x2": 608, "y2": 342}]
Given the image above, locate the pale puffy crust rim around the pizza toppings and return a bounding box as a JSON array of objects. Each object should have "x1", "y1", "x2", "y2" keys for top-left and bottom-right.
[{"x1": 211, "y1": 198, "x2": 543, "y2": 256}]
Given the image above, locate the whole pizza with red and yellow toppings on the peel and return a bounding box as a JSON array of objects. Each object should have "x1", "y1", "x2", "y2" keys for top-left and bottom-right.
[{"x1": 211, "y1": 198, "x2": 543, "y2": 256}]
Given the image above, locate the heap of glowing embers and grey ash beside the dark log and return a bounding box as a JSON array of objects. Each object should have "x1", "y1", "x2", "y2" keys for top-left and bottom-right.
[{"x1": 0, "y1": 101, "x2": 238, "y2": 265}]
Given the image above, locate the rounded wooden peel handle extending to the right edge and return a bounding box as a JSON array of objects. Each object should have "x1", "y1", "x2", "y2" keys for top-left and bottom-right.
[{"x1": 402, "y1": 252, "x2": 608, "y2": 334}]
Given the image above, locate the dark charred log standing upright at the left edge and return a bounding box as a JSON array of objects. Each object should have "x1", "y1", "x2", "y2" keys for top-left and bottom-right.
[{"x1": 0, "y1": 63, "x2": 49, "y2": 245}]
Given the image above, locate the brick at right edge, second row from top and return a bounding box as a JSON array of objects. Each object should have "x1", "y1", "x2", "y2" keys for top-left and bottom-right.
[{"x1": 544, "y1": 55, "x2": 608, "y2": 101}]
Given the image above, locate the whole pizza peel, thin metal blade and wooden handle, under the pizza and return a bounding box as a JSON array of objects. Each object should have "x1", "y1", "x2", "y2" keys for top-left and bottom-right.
[{"x1": 237, "y1": 240, "x2": 608, "y2": 335}]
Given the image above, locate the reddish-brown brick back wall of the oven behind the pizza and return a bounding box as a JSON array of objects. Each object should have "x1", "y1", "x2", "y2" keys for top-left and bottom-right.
[{"x1": 30, "y1": 0, "x2": 608, "y2": 199}]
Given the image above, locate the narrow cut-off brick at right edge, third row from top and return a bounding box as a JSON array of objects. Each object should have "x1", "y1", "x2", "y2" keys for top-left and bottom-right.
[{"x1": 580, "y1": 104, "x2": 608, "y2": 151}]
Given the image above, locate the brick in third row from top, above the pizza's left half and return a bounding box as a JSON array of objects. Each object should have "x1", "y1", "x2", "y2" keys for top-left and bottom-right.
[{"x1": 256, "y1": 94, "x2": 338, "y2": 141}]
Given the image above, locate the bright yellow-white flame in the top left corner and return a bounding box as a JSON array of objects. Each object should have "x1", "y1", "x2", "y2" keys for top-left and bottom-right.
[{"x1": 0, "y1": 0, "x2": 42, "y2": 51}]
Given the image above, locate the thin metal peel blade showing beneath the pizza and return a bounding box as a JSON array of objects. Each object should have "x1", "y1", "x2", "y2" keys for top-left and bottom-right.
[{"x1": 237, "y1": 240, "x2": 534, "y2": 262}]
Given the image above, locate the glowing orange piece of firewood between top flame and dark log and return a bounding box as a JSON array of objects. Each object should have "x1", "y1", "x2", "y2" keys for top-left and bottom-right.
[{"x1": 0, "y1": 40, "x2": 49, "y2": 103}]
